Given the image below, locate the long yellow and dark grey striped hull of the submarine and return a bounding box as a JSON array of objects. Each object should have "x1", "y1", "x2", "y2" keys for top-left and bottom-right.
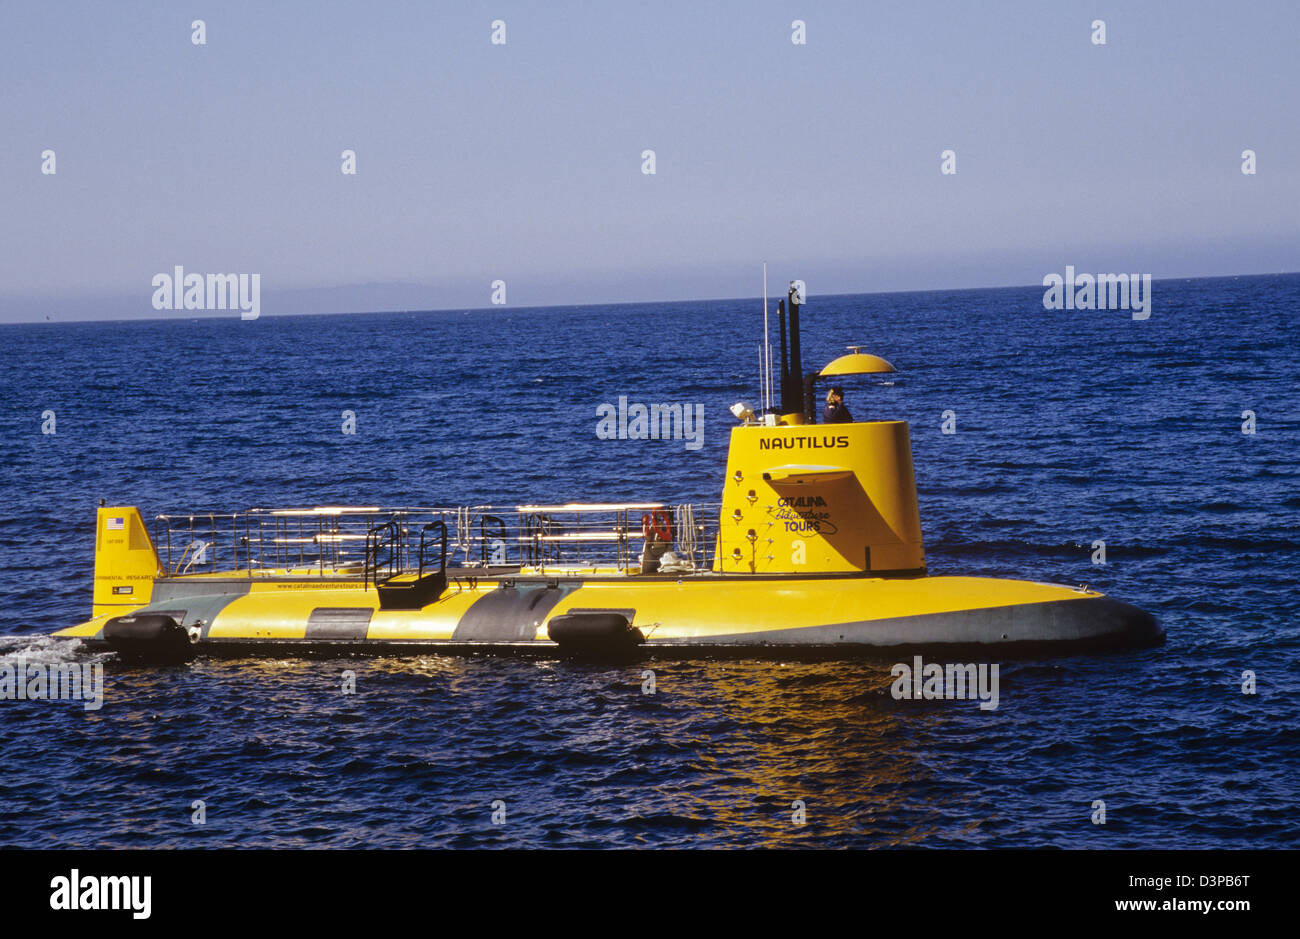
[{"x1": 56, "y1": 576, "x2": 1165, "y2": 658}]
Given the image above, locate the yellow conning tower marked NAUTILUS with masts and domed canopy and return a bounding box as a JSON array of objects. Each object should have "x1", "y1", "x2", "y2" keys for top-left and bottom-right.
[{"x1": 714, "y1": 274, "x2": 926, "y2": 576}]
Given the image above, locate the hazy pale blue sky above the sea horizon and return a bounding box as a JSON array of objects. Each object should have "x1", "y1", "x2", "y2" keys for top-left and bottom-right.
[{"x1": 0, "y1": 0, "x2": 1300, "y2": 320}]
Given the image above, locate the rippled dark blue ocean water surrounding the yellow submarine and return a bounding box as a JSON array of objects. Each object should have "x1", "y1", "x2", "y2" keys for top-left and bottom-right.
[{"x1": 0, "y1": 274, "x2": 1300, "y2": 848}]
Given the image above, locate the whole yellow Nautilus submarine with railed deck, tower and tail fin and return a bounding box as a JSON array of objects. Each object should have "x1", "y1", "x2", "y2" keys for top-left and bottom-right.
[{"x1": 55, "y1": 281, "x2": 1165, "y2": 661}]
